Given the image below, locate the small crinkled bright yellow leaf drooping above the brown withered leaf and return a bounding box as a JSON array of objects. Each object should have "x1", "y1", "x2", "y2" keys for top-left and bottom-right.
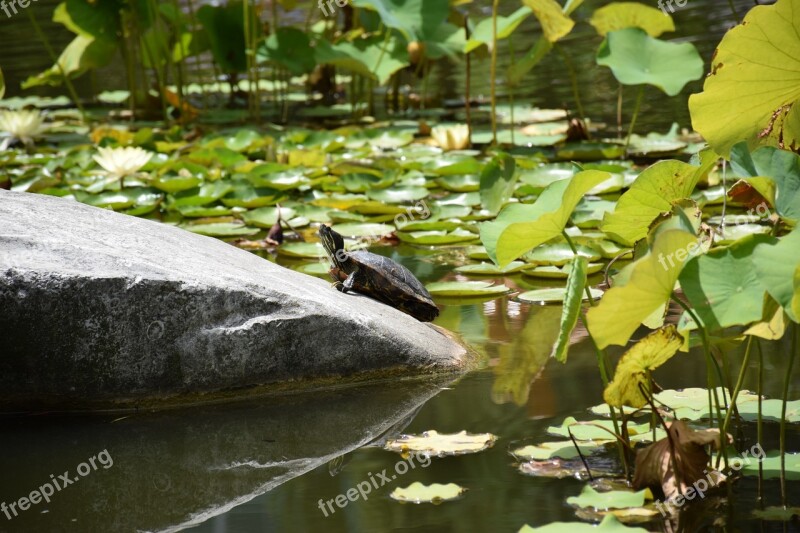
[{"x1": 603, "y1": 325, "x2": 683, "y2": 408}]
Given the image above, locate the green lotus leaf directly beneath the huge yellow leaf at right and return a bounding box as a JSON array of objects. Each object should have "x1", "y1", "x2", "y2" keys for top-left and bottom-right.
[{"x1": 731, "y1": 142, "x2": 800, "y2": 221}]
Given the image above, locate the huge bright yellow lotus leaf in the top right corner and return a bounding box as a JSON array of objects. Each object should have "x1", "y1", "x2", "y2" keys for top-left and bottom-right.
[{"x1": 689, "y1": 0, "x2": 800, "y2": 156}]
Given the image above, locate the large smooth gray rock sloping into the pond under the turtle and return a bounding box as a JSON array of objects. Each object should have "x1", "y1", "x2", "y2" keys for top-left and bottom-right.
[{"x1": 0, "y1": 191, "x2": 467, "y2": 410}]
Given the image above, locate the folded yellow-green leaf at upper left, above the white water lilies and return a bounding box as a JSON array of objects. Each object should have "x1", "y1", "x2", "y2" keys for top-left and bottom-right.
[{"x1": 22, "y1": 35, "x2": 117, "y2": 89}]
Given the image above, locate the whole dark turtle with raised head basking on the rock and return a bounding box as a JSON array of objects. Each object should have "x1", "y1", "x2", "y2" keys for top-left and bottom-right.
[{"x1": 319, "y1": 224, "x2": 439, "y2": 322}]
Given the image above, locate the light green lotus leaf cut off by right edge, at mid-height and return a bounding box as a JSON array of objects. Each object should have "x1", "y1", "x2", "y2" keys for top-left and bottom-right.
[{"x1": 753, "y1": 228, "x2": 800, "y2": 322}]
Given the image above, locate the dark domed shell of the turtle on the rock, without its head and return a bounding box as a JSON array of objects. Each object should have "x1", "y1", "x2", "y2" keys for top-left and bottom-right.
[{"x1": 347, "y1": 251, "x2": 439, "y2": 322}]
